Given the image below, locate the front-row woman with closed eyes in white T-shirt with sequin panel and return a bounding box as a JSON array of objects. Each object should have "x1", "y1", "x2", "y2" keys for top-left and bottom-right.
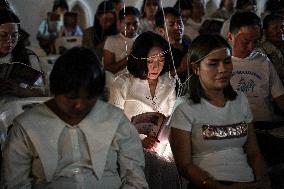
[{"x1": 170, "y1": 35, "x2": 270, "y2": 189}]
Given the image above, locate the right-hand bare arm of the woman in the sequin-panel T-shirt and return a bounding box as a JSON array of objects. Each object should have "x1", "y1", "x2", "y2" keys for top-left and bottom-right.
[{"x1": 244, "y1": 123, "x2": 270, "y2": 189}]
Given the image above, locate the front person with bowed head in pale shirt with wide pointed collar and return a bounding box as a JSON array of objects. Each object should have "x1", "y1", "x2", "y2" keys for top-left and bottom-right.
[{"x1": 1, "y1": 47, "x2": 148, "y2": 189}]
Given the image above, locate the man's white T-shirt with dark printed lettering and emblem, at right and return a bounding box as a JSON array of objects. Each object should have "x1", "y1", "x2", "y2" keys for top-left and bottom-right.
[{"x1": 231, "y1": 52, "x2": 284, "y2": 121}]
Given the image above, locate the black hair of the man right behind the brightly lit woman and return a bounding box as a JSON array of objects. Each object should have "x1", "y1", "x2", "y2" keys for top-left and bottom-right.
[{"x1": 155, "y1": 7, "x2": 181, "y2": 28}]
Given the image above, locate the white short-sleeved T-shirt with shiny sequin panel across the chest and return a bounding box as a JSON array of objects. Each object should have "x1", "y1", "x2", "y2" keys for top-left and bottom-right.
[{"x1": 170, "y1": 92, "x2": 254, "y2": 182}]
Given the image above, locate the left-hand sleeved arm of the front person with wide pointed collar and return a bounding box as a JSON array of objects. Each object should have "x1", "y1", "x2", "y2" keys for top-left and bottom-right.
[{"x1": 1, "y1": 123, "x2": 33, "y2": 189}]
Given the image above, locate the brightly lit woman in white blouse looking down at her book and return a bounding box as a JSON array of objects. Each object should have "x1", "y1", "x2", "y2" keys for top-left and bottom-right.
[{"x1": 110, "y1": 32, "x2": 179, "y2": 189}]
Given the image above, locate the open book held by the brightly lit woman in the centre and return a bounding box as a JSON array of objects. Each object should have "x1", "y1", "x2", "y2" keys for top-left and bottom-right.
[{"x1": 131, "y1": 112, "x2": 168, "y2": 138}]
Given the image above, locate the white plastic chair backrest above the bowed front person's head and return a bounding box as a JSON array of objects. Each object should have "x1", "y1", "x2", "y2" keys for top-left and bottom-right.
[{"x1": 55, "y1": 36, "x2": 82, "y2": 54}]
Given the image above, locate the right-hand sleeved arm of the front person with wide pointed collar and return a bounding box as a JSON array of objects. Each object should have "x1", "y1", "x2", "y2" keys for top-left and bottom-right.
[{"x1": 117, "y1": 116, "x2": 148, "y2": 189}]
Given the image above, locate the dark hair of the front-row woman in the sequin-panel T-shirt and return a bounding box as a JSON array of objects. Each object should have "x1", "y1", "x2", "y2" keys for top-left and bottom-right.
[{"x1": 188, "y1": 34, "x2": 237, "y2": 103}]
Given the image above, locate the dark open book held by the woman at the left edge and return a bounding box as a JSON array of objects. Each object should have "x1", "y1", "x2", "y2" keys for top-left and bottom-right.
[{"x1": 0, "y1": 62, "x2": 43, "y2": 87}]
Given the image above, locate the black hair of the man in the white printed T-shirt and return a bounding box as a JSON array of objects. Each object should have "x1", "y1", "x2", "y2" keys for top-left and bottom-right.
[{"x1": 229, "y1": 12, "x2": 262, "y2": 34}]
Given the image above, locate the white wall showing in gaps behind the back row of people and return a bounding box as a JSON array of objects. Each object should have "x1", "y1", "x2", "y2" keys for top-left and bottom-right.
[{"x1": 8, "y1": 0, "x2": 266, "y2": 46}]
